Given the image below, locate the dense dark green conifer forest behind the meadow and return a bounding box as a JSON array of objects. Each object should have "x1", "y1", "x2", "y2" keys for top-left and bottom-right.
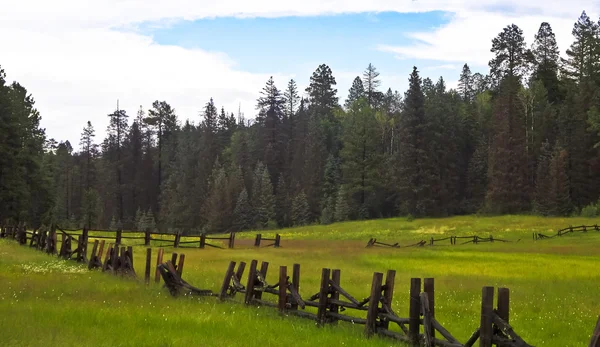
[{"x1": 0, "y1": 12, "x2": 600, "y2": 233}]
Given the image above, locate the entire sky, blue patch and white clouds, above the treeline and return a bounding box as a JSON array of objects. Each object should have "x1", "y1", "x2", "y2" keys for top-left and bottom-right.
[{"x1": 0, "y1": 0, "x2": 600, "y2": 150}]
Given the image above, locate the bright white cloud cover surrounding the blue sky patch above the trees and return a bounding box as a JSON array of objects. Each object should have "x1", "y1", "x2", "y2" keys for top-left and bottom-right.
[{"x1": 0, "y1": 0, "x2": 599, "y2": 144}]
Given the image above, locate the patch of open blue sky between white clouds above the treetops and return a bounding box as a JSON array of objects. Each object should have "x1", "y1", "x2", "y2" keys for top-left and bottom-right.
[{"x1": 136, "y1": 11, "x2": 477, "y2": 100}]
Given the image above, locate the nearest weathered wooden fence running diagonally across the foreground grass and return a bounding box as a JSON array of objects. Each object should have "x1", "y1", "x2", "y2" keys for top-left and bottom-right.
[{"x1": 2, "y1": 228, "x2": 600, "y2": 347}]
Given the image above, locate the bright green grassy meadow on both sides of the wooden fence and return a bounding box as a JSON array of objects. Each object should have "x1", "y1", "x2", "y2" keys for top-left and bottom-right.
[{"x1": 0, "y1": 216, "x2": 600, "y2": 346}]
